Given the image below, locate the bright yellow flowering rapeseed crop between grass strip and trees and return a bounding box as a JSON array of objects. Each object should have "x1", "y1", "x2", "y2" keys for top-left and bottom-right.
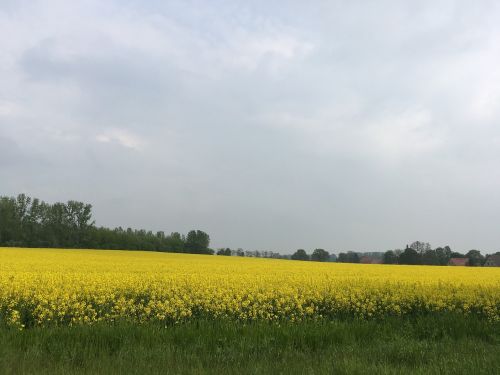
[{"x1": 0, "y1": 248, "x2": 500, "y2": 328}]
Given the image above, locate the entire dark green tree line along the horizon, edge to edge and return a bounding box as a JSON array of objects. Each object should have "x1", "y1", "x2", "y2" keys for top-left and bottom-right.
[{"x1": 0, "y1": 194, "x2": 500, "y2": 266}]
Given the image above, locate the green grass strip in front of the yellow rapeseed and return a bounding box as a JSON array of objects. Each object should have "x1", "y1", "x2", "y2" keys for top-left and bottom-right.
[{"x1": 0, "y1": 316, "x2": 500, "y2": 374}]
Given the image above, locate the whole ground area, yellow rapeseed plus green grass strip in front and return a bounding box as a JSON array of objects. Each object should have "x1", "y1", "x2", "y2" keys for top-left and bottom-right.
[{"x1": 0, "y1": 248, "x2": 500, "y2": 374}]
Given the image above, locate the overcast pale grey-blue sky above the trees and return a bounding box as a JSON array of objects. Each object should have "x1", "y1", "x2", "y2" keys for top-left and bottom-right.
[{"x1": 0, "y1": 0, "x2": 500, "y2": 253}]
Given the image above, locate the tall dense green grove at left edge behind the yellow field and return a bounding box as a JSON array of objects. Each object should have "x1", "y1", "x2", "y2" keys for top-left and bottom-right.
[{"x1": 0, "y1": 194, "x2": 213, "y2": 254}]
